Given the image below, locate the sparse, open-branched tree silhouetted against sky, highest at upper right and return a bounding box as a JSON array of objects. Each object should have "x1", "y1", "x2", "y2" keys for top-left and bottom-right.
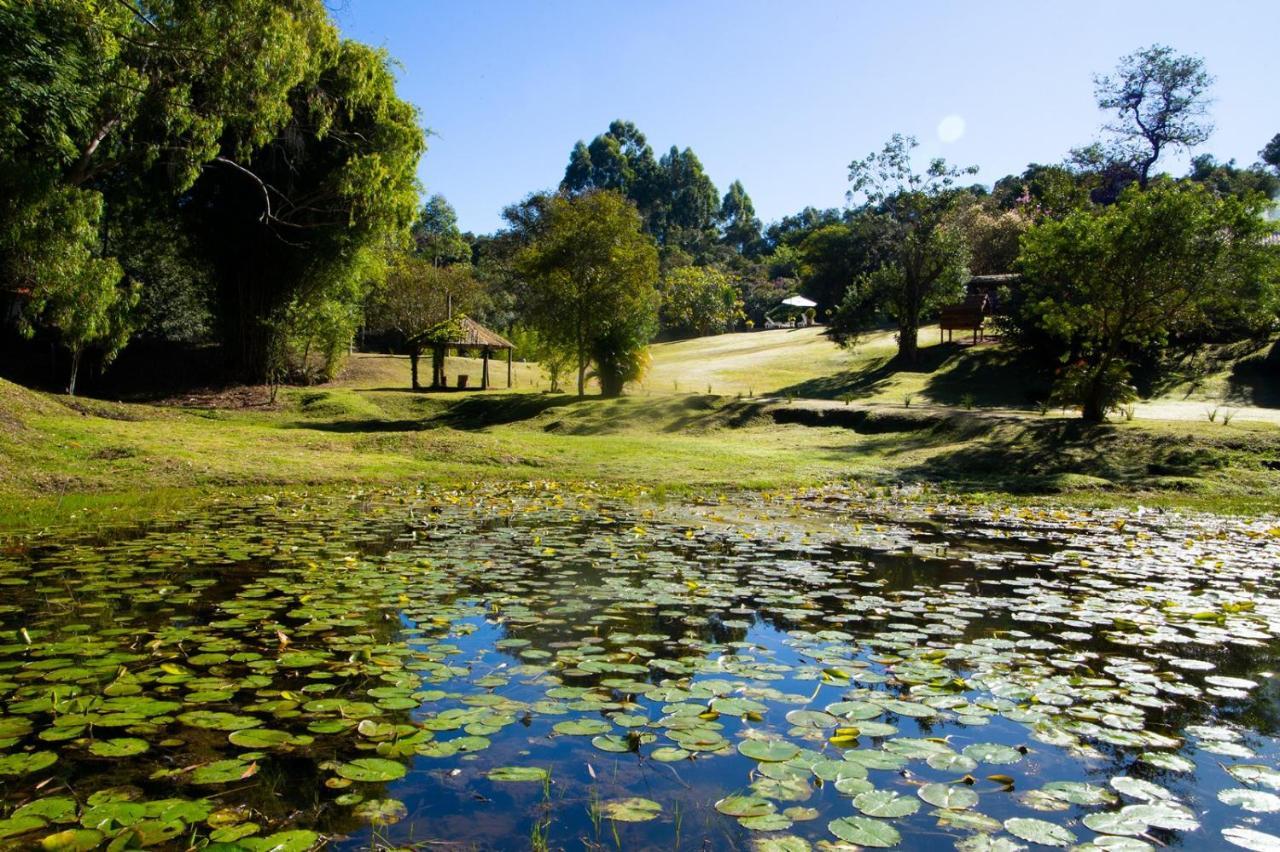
[{"x1": 1093, "y1": 45, "x2": 1213, "y2": 189}]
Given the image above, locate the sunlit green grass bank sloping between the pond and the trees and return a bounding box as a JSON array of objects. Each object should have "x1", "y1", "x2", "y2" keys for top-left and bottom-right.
[{"x1": 0, "y1": 329, "x2": 1280, "y2": 527}]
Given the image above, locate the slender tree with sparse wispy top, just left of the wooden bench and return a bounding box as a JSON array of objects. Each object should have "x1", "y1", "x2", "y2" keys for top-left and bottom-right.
[{"x1": 849, "y1": 133, "x2": 977, "y2": 363}]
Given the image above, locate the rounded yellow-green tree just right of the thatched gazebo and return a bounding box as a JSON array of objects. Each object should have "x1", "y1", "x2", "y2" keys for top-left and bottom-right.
[{"x1": 516, "y1": 189, "x2": 658, "y2": 397}]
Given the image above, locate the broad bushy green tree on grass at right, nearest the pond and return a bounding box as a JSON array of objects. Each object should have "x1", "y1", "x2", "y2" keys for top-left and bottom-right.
[{"x1": 1018, "y1": 182, "x2": 1280, "y2": 422}]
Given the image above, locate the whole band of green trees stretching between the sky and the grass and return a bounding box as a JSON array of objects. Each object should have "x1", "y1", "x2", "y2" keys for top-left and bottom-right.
[{"x1": 0, "y1": 10, "x2": 1280, "y2": 416}]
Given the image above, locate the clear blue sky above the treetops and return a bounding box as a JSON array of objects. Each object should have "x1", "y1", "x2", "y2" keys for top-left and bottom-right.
[{"x1": 335, "y1": 0, "x2": 1280, "y2": 233}]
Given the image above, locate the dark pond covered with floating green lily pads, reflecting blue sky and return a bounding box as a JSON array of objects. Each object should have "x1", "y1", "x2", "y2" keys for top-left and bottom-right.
[{"x1": 0, "y1": 484, "x2": 1280, "y2": 852}]
